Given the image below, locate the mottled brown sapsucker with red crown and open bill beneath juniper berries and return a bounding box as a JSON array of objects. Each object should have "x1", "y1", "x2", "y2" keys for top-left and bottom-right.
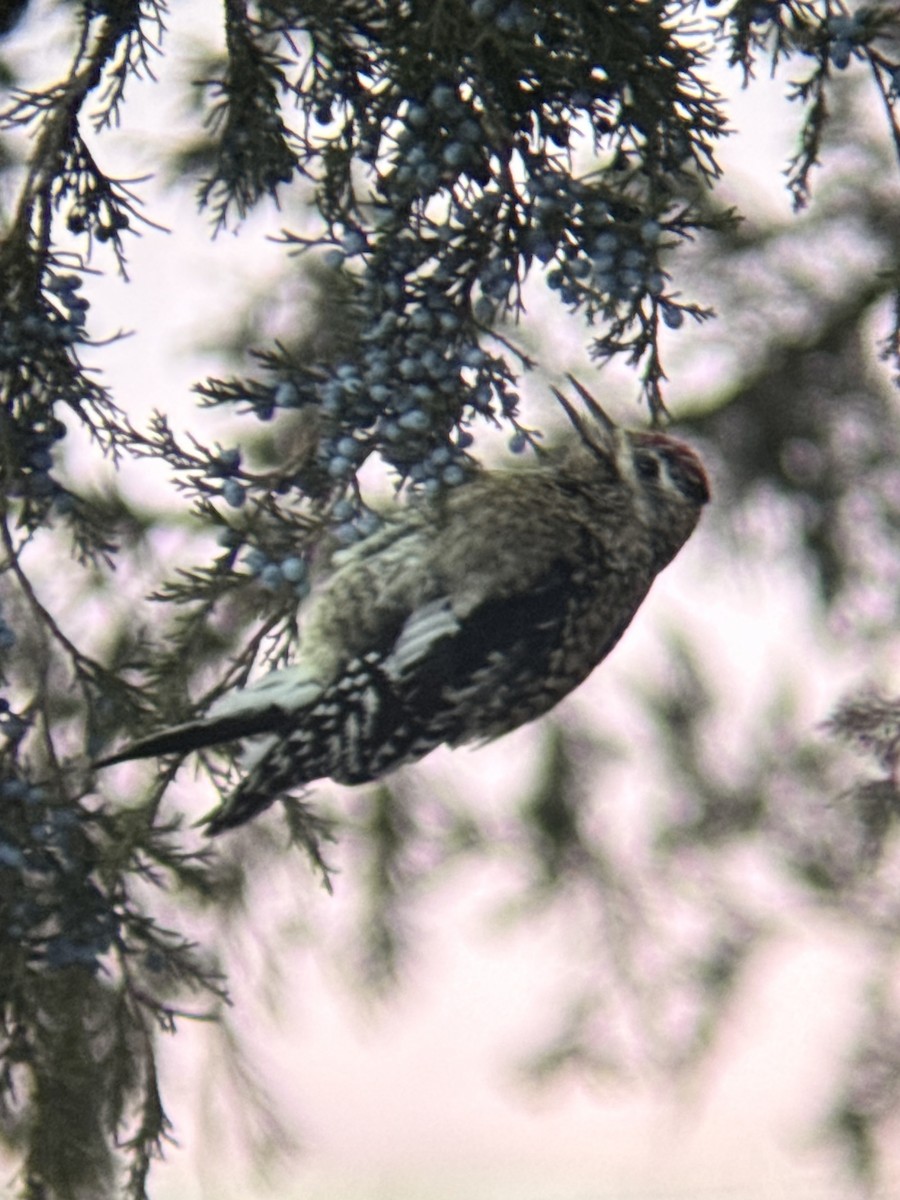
[{"x1": 100, "y1": 385, "x2": 709, "y2": 833}]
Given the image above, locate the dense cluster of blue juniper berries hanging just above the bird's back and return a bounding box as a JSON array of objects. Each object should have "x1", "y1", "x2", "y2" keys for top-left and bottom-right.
[{"x1": 307, "y1": 211, "x2": 504, "y2": 491}]
